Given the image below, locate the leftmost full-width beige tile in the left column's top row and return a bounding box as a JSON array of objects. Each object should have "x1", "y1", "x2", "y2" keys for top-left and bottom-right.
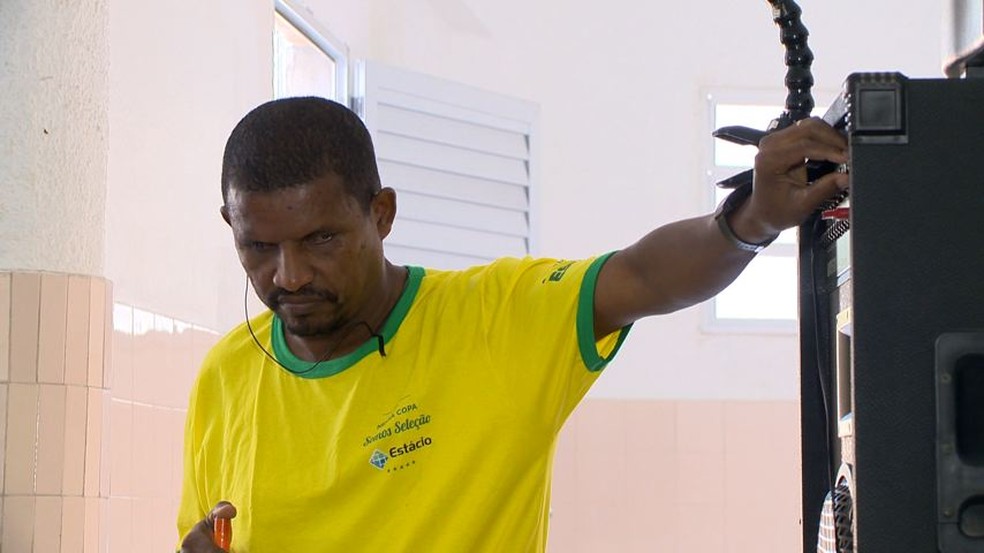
[{"x1": 10, "y1": 273, "x2": 41, "y2": 383}]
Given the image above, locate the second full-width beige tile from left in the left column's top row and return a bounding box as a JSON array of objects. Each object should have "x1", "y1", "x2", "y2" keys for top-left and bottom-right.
[{"x1": 38, "y1": 273, "x2": 68, "y2": 384}]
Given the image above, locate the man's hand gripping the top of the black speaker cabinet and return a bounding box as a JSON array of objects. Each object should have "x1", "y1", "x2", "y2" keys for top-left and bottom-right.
[{"x1": 729, "y1": 117, "x2": 849, "y2": 244}]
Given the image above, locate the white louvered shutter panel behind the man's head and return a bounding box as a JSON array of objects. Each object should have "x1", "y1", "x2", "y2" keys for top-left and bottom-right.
[{"x1": 355, "y1": 63, "x2": 537, "y2": 269}]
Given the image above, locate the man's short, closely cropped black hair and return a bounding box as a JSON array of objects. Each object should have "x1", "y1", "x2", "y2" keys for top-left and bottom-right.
[{"x1": 222, "y1": 96, "x2": 381, "y2": 212}]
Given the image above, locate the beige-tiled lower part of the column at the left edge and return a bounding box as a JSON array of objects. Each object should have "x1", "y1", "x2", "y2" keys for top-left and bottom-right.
[{"x1": 0, "y1": 272, "x2": 112, "y2": 553}]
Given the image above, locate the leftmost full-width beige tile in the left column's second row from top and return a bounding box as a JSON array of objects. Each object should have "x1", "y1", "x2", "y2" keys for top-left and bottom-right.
[{"x1": 4, "y1": 384, "x2": 40, "y2": 495}]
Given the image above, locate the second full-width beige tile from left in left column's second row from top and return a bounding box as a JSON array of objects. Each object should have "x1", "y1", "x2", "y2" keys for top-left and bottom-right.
[{"x1": 35, "y1": 384, "x2": 65, "y2": 494}]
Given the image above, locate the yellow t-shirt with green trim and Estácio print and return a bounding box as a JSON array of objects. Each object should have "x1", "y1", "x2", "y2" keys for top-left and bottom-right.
[{"x1": 178, "y1": 256, "x2": 628, "y2": 553}]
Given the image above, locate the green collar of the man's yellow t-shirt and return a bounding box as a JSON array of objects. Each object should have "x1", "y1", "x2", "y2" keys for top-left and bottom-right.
[{"x1": 271, "y1": 267, "x2": 424, "y2": 378}]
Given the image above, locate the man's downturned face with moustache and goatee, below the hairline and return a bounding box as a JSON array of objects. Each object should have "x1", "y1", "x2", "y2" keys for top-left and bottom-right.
[{"x1": 222, "y1": 175, "x2": 393, "y2": 337}]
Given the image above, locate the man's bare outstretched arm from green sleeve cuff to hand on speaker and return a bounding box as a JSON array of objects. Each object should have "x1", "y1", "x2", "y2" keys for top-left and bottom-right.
[{"x1": 594, "y1": 119, "x2": 848, "y2": 337}]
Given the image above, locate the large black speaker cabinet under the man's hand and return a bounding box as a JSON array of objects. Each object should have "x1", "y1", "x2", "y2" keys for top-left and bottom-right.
[{"x1": 800, "y1": 73, "x2": 984, "y2": 553}]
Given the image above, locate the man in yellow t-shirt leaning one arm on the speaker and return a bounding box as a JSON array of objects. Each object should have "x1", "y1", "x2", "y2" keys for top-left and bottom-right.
[{"x1": 178, "y1": 98, "x2": 847, "y2": 553}]
